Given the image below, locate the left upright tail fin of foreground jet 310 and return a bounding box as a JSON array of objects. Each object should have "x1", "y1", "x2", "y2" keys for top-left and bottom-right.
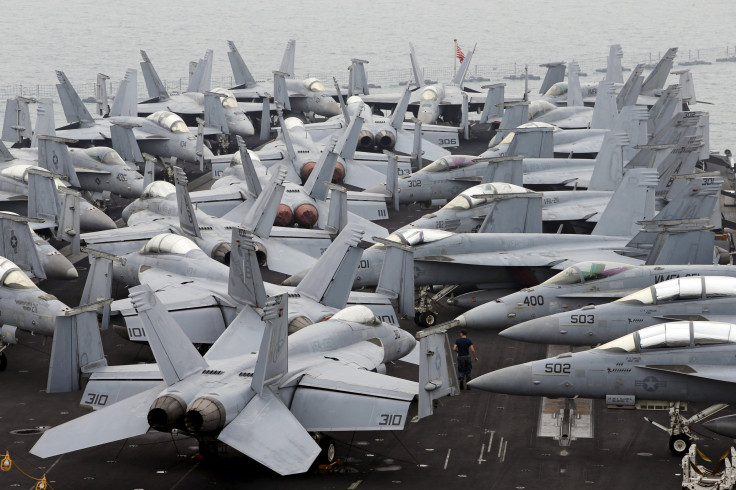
[{"x1": 130, "y1": 285, "x2": 207, "y2": 386}]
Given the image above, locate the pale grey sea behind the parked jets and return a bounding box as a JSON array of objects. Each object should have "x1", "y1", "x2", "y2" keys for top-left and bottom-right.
[{"x1": 0, "y1": 0, "x2": 736, "y2": 151}]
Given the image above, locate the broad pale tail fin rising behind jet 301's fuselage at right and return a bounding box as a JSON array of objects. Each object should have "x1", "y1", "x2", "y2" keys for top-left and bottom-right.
[{"x1": 591, "y1": 168, "x2": 659, "y2": 236}]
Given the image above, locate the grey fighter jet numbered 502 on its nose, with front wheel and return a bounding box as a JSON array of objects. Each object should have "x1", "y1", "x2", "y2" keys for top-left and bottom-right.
[{"x1": 468, "y1": 321, "x2": 736, "y2": 456}]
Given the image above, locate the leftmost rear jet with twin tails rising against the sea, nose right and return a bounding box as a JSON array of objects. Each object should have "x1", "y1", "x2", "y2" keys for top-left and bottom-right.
[{"x1": 56, "y1": 69, "x2": 219, "y2": 167}]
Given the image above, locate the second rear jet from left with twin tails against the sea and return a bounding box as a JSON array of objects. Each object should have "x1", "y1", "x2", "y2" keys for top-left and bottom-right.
[{"x1": 138, "y1": 49, "x2": 255, "y2": 137}]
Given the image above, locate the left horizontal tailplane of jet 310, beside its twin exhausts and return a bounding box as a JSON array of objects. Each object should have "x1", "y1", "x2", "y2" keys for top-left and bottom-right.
[{"x1": 31, "y1": 386, "x2": 163, "y2": 458}]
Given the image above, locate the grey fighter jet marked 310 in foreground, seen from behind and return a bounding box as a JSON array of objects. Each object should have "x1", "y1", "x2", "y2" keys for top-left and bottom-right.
[{"x1": 31, "y1": 286, "x2": 453, "y2": 475}]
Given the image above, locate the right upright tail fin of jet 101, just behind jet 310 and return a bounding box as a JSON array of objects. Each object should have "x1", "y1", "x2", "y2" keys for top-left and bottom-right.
[{"x1": 294, "y1": 225, "x2": 363, "y2": 309}]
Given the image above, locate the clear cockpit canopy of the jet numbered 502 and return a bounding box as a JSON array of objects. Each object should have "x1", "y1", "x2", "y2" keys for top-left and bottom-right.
[{"x1": 596, "y1": 321, "x2": 736, "y2": 352}]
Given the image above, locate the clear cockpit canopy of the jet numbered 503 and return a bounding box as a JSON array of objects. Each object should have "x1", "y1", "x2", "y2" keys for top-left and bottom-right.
[{"x1": 616, "y1": 276, "x2": 736, "y2": 305}]
